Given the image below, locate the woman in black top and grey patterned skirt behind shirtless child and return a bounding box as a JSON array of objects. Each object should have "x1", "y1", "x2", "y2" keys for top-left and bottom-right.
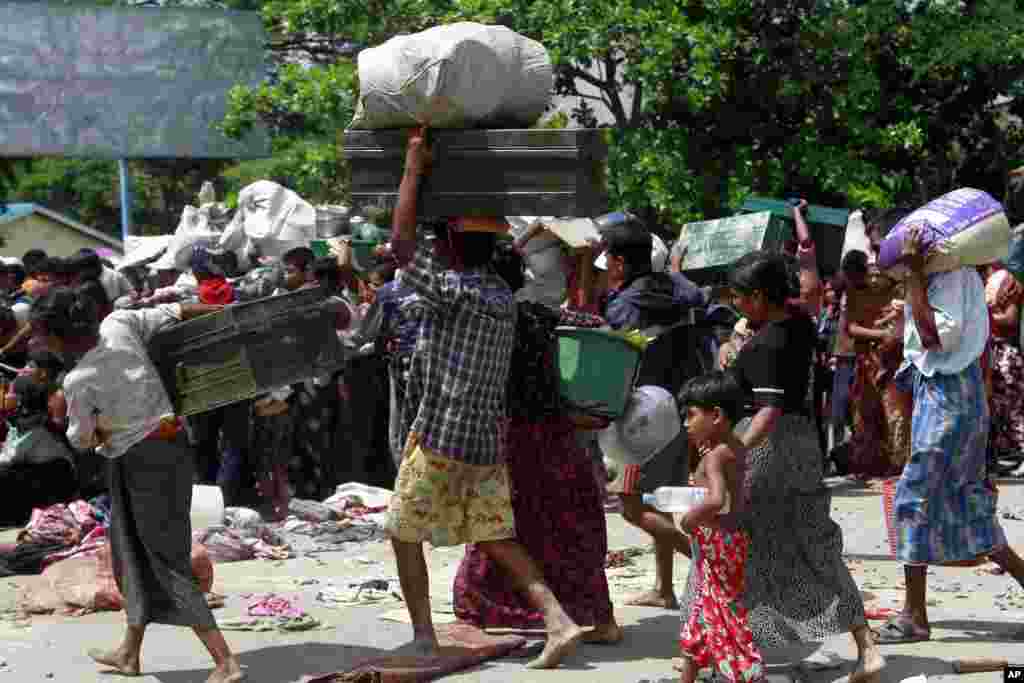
[{"x1": 683, "y1": 252, "x2": 885, "y2": 683}]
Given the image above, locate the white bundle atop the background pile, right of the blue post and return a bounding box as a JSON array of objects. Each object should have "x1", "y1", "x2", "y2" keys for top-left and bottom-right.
[{"x1": 218, "y1": 180, "x2": 316, "y2": 263}]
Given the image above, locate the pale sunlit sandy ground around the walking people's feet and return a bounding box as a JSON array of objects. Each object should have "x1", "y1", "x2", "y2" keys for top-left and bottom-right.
[{"x1": 0, "y1": 480, "x2": 1024, "y2": 683}]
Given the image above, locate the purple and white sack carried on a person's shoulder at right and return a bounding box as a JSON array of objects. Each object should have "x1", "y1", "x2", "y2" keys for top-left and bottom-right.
[{"x1": 879, "y1": 187, "x2": 1010, "y2": 273}]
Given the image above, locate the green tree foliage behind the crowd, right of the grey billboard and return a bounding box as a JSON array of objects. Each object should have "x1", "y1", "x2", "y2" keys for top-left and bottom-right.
[{"x1": 6, "y1": 0, "x2": 1024, "y2": 237}]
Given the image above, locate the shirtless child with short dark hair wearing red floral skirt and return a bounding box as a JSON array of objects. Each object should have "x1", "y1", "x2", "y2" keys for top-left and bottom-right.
[{"x1": 679, "y1": 372, "x2": 765, "y2": 683}]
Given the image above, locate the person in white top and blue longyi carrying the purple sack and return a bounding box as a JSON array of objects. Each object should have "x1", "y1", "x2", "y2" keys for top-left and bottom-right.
[{"x1": 868, "y1": 221, "x2": 1024, "y2": 643}]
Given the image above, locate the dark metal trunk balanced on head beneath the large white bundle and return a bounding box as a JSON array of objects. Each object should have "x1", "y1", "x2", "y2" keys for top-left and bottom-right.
[{"x1": 342, "y1": 129, "x2": 608, "y2": 218}]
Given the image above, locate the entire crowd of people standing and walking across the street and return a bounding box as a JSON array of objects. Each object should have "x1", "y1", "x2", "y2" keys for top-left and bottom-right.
[{"x1": 0, "y1": 126, "x2": 1024, "y2": 683}]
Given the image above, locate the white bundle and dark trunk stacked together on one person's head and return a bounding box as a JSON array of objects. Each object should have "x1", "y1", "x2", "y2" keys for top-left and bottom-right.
[{"x1": 344, "y1": 23, "x2": 607, "y2": 217}]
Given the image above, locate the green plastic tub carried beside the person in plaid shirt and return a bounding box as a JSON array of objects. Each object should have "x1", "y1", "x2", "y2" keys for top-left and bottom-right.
[{"x1": 556, "y1": 328, "x2": 640, "y2": 418}]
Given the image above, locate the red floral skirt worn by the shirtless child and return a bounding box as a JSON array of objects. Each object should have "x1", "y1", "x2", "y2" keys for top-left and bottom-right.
[{"x1": 680, "y1": 526, "x2": 766, "y2": 683}]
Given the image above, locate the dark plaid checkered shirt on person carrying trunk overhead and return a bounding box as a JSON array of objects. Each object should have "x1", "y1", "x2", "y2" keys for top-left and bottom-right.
[{"x1": 402, "y1": 245, "x2": 516, "y2": 465}]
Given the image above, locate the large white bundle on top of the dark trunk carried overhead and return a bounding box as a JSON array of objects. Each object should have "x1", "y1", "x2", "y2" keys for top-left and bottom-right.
[{"x1": 351, "y1": 22, "x2": 554, "y2": 129}]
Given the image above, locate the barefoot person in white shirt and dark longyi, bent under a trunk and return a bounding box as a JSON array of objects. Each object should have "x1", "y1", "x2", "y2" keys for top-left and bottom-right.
[{"x1": 32, "y1": 288, "x2": 244, "y2": 683}]
